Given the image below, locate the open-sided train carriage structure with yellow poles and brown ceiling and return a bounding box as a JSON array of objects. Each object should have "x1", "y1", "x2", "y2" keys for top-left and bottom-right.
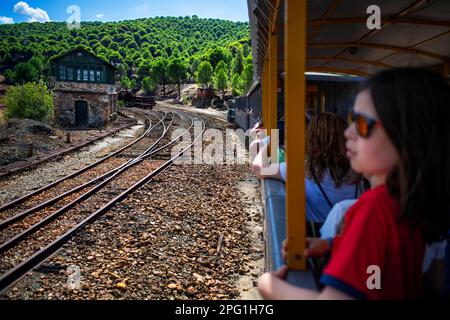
[{"x1": 237, "y1": 0, "x2": 450, "y2": 296}]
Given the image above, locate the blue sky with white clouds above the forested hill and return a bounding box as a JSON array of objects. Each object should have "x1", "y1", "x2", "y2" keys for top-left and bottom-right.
[{"x1": 0, "y1": 0, "x2": 248, "y2": 24}]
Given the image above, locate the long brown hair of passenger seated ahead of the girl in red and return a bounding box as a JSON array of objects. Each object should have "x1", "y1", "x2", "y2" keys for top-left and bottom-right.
[{"x1": 306, "y1": 113, "x2": 350, "y2": 187}]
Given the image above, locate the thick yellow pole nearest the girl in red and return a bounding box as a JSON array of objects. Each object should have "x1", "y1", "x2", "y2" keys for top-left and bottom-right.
[{"x1": 284, "y1": 0, "x2": 306, "y2": 270}]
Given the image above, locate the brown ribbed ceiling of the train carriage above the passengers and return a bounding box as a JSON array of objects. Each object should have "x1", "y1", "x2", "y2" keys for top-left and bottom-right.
[{"x1": 247, "y1": 0, "x2": 450, "y2": 77}]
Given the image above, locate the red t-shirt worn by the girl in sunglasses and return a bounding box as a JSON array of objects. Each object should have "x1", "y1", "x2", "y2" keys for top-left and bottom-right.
[{"x1": 320, "y1": 185, "x2": 425, "y2": 299}]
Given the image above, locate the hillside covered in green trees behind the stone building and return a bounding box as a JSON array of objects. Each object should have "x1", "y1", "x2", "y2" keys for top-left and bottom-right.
[{"x1": 0, "y1": 16, "x2": 253, "y2": 94}]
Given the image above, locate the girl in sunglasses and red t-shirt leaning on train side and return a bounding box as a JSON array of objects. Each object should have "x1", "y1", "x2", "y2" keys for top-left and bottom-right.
[{"x1": 258, "y1": 68, "x2": 450, "y2": 299}]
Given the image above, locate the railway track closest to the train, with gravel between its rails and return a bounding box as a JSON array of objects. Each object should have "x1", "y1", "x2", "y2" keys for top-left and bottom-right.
[{"x1": 0, "y1": 107, "x2": 205, "y2": 292}]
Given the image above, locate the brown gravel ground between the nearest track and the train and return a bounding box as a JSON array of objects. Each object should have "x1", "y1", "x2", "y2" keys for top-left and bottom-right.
[{"x1": 1, "y1": 105, "x2": 264, "y2": 300}]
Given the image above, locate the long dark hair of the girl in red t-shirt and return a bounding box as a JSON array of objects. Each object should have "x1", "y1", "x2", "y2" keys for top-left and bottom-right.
[{"x1": 360, "y1": 68, "x2": 450, "y2": 243}]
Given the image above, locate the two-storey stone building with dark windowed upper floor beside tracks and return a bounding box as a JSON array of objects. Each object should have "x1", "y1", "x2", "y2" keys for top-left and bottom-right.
[{"x1": 52, "y1": 48, "x2": 117, "y2": 128}]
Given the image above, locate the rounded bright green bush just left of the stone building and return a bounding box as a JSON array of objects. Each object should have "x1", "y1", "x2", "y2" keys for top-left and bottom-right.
[{"x1": 5, "y1": 83, "x2": 54, "y2": 121}]
